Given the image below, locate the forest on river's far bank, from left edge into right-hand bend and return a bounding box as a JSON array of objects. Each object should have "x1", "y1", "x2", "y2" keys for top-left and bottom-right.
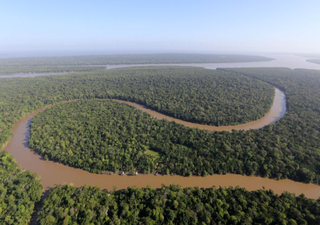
[{"x1": 0, "y1": 67, "x2": 274, "y2": 151}]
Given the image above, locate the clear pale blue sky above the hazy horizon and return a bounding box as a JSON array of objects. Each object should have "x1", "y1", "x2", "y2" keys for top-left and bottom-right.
[{"x1": 0, "y1": 0, "x2": 320, "y2": 54}]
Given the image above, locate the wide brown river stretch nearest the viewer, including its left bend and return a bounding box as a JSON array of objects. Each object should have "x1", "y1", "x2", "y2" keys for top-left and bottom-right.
[{"x1": 4, "y1": 107, "x2": 320, "y2": 199}]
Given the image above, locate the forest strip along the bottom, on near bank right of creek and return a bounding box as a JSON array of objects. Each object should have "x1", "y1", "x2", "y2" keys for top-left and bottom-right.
[{"x1": 38, "y1": 185, "x2": 320, "y2": 225}]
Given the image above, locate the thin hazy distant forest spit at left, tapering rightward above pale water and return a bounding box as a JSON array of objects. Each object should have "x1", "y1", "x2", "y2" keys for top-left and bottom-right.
[{"x1": 0, "y1": 66, "x2": 105, "y2": 76}]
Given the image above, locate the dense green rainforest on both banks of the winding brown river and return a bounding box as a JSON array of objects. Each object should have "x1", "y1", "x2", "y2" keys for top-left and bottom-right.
[{"x1": 0, "y1": 62, "x2": 320, "y2": 224}]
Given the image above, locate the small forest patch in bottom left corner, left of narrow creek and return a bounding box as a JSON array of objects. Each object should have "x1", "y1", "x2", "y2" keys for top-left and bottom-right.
[{"x1": 0, "y1": 151, "x2": 42, "y2": 224}]
